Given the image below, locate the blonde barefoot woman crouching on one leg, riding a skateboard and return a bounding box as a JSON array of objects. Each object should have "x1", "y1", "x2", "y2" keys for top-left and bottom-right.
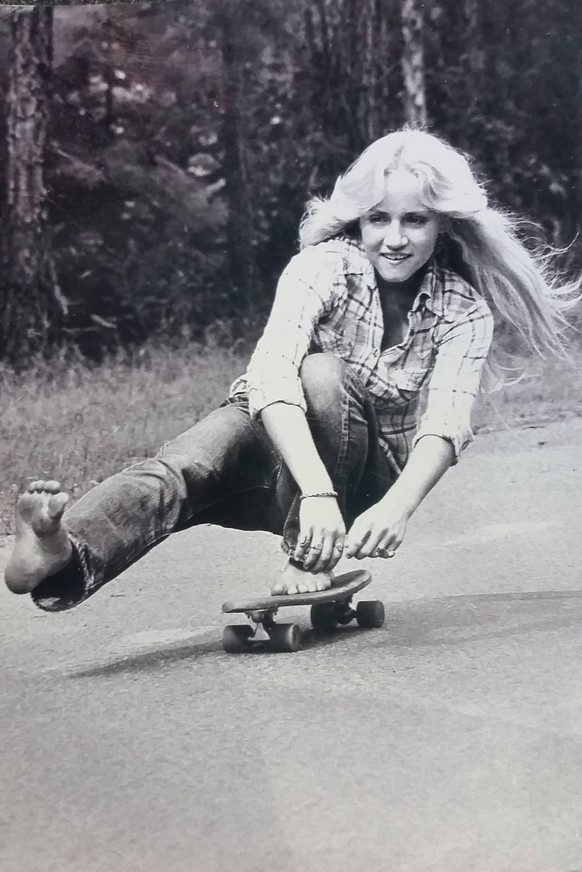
[{"x1": 6, "y1": 130, "x2": 576, "y2": 610}]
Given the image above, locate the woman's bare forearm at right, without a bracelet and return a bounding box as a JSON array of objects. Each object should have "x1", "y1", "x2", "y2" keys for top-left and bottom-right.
[{"x1": 381, "y1": 435, "x2": 454, "y2": 518}]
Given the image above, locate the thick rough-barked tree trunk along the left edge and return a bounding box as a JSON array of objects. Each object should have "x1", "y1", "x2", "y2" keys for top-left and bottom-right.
[{"x1": 0, "y1": 7, "x2": 64, "y2": 362}]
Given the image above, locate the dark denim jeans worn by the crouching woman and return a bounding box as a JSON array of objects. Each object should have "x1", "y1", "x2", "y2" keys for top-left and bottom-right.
[{"x1": 32, "y1": 354, "x2": 394, "y2": 611}]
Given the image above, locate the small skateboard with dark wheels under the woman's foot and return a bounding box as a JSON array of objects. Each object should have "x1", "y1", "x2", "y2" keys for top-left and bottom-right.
[{"x1": 222, "y1": 570, "x2": 384, "y2": 654}]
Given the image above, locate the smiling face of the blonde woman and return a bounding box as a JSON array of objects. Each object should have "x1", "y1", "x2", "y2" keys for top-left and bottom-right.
[{"x1": 360, "y1": 170, "x2": 440, "y2": 283}]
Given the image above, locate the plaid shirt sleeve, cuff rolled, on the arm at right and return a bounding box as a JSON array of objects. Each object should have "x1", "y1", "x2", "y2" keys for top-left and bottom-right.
[{"x1": 413, "y1": 300, "x2": 493, "y2": 463}]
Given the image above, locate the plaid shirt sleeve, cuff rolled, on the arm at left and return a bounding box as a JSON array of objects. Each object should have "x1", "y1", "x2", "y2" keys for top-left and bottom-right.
[{"x1": 246, "y1": 244, "x2": 342, "y2": 417}]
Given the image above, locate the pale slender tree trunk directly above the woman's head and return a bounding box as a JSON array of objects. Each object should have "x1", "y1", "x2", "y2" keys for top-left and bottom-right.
[{"x1": 401, "y1": 0, "x2": 427, "y2": 127}]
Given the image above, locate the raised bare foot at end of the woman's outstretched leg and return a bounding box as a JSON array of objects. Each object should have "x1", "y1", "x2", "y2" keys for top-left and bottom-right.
[{"x1": 4, "y1": 481, "x2": 72, "y2": 593}]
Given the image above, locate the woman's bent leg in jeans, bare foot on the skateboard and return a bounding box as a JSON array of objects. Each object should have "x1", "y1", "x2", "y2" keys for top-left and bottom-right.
[{"x1": 276, "y1": 354, "x2": 394, "y2": 593}]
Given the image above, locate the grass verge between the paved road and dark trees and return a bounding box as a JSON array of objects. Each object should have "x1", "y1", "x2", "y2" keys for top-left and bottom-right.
[{"x1": 0, "y1": 344, "x2": 582, "y2": 535}]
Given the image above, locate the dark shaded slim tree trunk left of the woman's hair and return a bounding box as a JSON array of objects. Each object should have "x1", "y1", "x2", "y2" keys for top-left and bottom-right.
[{"x1": 218, "y1": 2, "x2": 258, "y2": 310}]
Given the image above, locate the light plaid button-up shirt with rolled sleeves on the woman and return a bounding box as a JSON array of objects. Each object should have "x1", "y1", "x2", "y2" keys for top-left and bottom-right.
[{"x1": 230, "y1": 238, "x2": 493, "y2": 472}]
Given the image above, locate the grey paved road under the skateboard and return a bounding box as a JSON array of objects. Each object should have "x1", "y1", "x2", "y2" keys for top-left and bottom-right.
[{"x1": 0, "y1": 421, "x2": 582, "y2": 872}]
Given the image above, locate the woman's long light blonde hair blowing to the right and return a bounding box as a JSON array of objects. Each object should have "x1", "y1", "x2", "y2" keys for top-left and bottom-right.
[{"x1": 300, "y1": 130, "x2": 581, "y2": 370}]
